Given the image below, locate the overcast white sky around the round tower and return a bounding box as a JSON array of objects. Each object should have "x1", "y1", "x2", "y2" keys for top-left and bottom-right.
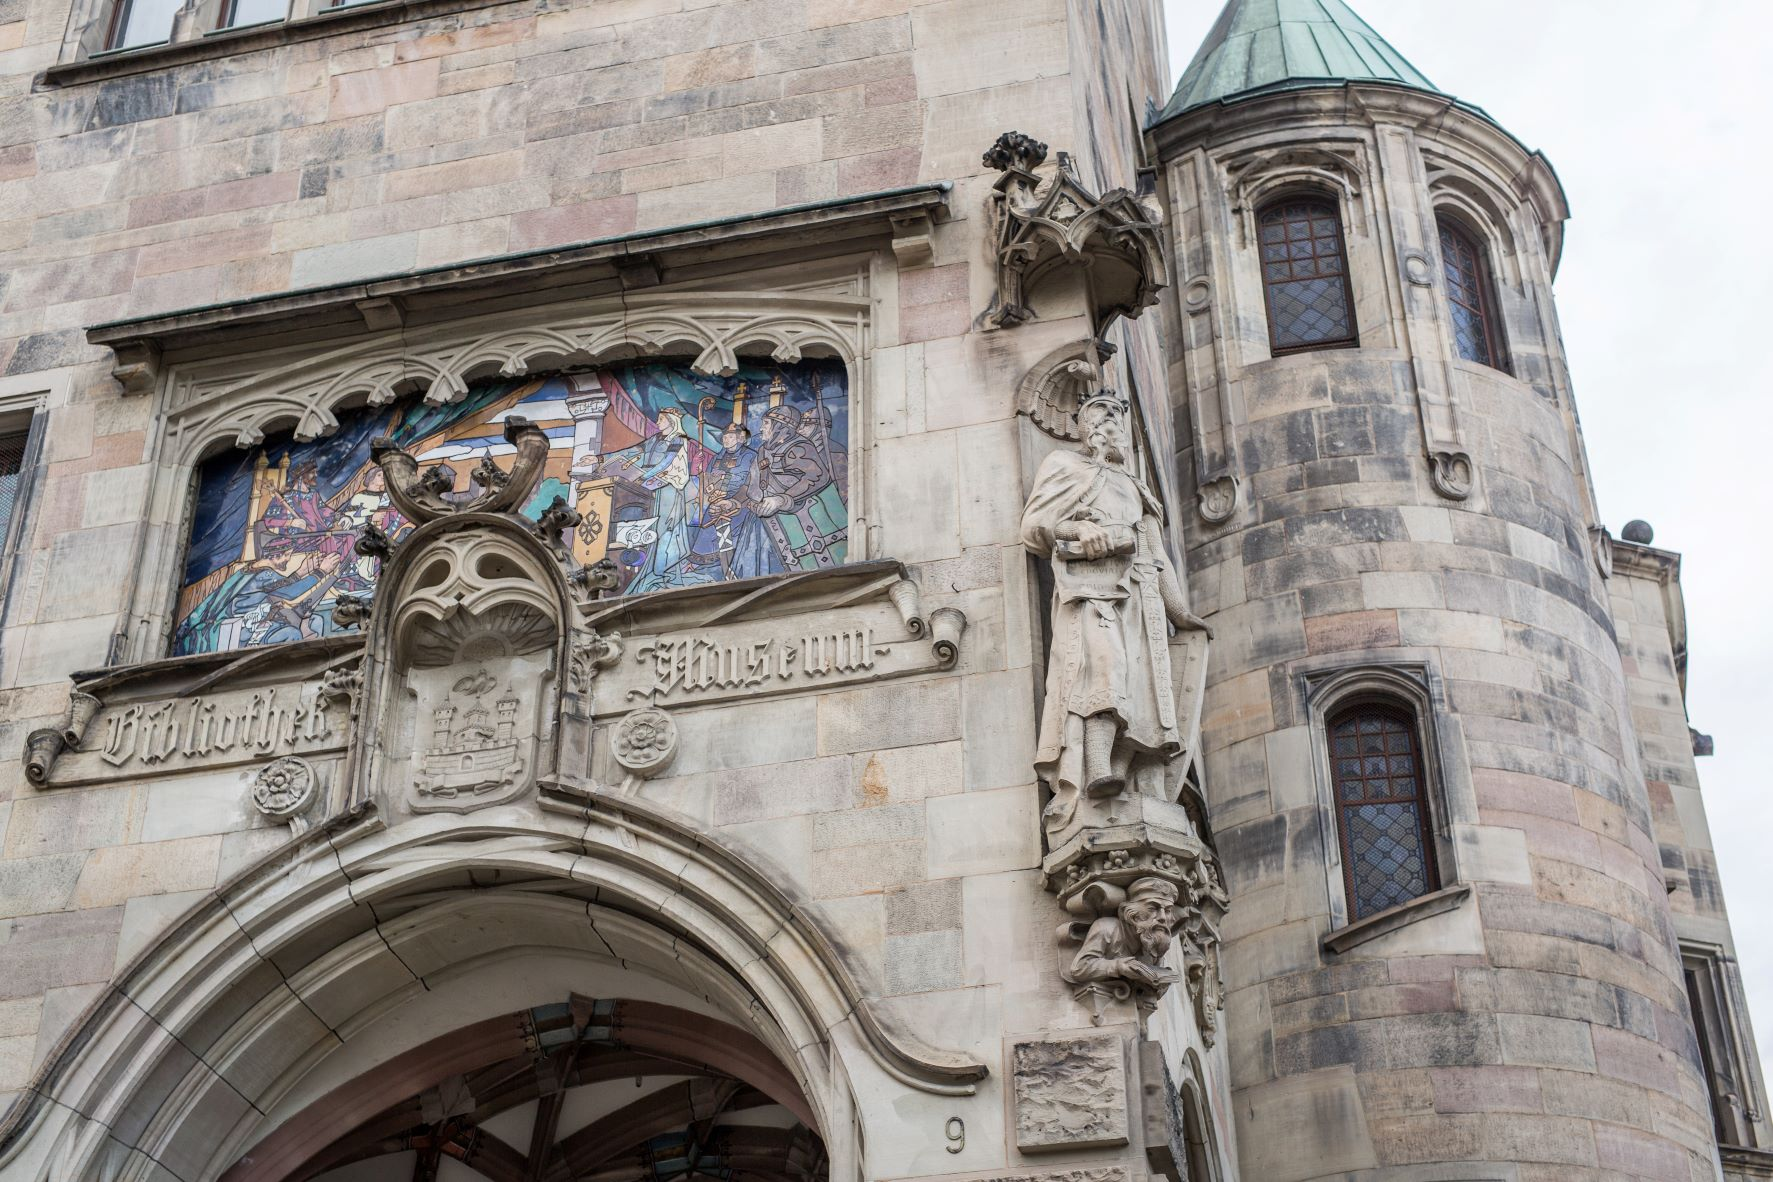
[{"x1": 1165, "y1": 0, "x2": 1773, "y2": 1070}]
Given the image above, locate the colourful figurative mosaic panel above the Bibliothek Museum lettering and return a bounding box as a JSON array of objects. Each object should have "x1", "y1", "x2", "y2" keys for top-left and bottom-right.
[{"x1": 172, "y1": 360, "x2": 849, "y2": 654}]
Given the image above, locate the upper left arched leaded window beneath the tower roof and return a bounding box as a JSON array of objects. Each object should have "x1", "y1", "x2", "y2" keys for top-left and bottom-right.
[{"x1": 1257, "y1": 197, "x2": 1355, "y2": 353}]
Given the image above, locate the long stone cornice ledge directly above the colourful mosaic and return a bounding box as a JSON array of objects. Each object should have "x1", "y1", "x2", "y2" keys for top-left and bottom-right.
[{"x1": 87, "y1": 181, "x2": 952, "y2": 361}]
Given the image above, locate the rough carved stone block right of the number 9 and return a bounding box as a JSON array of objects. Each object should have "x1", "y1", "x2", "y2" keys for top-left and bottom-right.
[{"x1": 1011, "y1": 1035, "x2": 1129, "y2": 1154}]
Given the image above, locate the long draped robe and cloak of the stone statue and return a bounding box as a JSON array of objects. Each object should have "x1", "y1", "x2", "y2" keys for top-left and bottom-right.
[{"x1": 1021, "y1": 452, "x2": 1183, "y2": 812}]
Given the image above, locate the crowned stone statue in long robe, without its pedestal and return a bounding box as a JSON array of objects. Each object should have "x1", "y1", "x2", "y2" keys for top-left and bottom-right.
[{"x1": 1021, "y1": 390, "x2": 1206, "y2": 831}]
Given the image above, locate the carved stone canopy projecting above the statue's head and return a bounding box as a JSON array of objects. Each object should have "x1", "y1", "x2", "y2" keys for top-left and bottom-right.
[{"x1": 984, "y1": 131, "x2": 1165, "y2": 330}]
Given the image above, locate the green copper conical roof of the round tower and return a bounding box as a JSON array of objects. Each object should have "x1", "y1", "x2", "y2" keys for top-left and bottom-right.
[{"x1": 1158, "y1": 0, "x2": 1440, "y2": 122}]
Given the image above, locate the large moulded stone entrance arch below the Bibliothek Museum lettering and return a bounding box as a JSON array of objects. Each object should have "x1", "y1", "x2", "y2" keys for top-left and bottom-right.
[{"x1": 0, "y1": 794, "x2": 996, "y2": 1182}]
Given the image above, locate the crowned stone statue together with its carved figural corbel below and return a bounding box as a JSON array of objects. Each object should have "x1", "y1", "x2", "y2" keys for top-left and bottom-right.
[{"x1": 1021, "y1": 390, "x2": 1225, "y2": 1038}]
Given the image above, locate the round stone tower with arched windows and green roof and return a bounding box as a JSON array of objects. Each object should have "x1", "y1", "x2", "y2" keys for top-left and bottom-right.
[{"x1": 1151, "y1": 0, "x2": 1714, "y2": 1182}]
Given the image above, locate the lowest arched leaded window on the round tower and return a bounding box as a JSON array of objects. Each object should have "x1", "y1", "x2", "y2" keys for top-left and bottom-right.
[{"x1": 1328, "y1": 702, "x2": 1440, "y2": 920}]
